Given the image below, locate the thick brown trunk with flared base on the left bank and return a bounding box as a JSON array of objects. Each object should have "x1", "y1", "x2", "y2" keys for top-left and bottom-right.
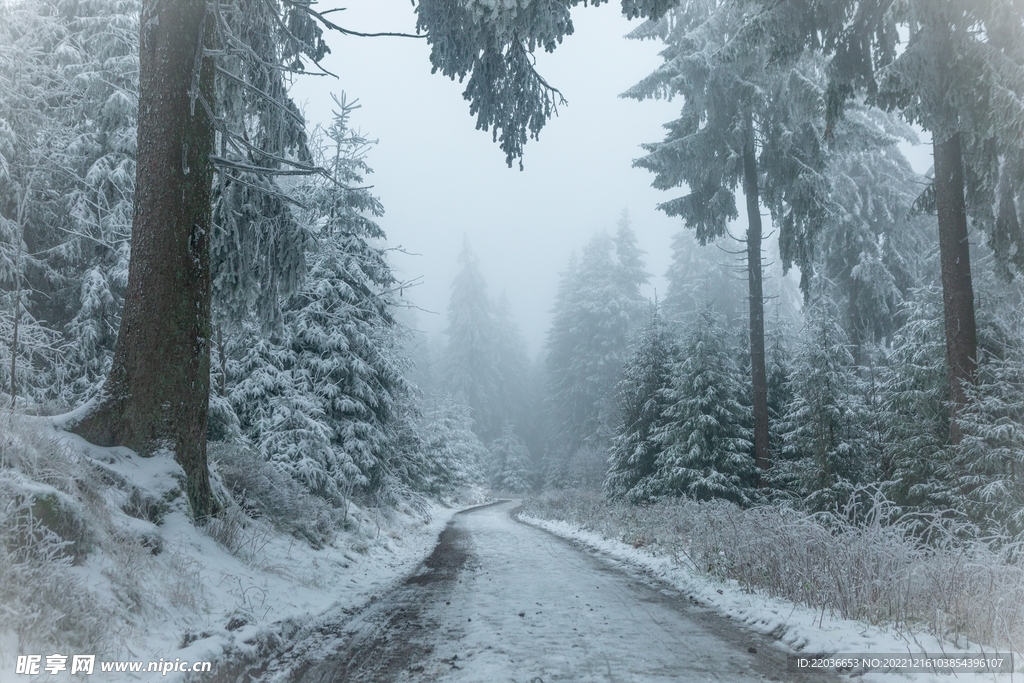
[{"x1": 76, "y1": 0, "x2": 214, "y2": 518}]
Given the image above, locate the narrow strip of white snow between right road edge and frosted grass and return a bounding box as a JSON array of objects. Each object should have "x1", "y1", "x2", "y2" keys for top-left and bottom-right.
[{"x1": 519, "y1": 515, "x2": 1021, "y2": 683}]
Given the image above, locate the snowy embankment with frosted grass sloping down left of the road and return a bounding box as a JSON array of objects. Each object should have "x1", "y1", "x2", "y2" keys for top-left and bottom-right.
[{"x1": 0, "y1": 414, "x2": 471, "y2": 682}]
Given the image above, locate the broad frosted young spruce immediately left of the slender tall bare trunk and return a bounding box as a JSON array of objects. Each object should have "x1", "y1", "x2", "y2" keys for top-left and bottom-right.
[{"x1": 643, "y1": 302, "x2": 758, "y2": 505}]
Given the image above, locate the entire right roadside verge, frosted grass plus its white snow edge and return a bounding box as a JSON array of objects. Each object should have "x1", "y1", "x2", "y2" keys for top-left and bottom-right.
[{"x1": 518, "y1": 492, "x2": 1024, "y2": 683}]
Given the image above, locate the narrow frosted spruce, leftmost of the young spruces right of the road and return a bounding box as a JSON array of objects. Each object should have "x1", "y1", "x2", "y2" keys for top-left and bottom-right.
[{"x1": 604, "y1": 307, "x2": 680, "y2": 503}]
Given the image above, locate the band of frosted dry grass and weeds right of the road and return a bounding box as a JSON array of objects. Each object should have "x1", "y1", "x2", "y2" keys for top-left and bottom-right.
[{"x1": 522, "y1": 490, "x2": 1024, "y2": 651}]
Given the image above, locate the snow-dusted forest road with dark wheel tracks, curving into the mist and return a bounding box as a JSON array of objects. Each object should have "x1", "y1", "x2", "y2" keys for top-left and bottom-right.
[{"x1": 258, "y1": 503, "x2": 839, "y2": 683}]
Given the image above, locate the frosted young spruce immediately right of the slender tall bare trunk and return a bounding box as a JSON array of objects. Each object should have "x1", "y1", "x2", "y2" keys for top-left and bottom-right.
[{"x1": 773, "y1": 297, "x2": 876, "y2": 510}]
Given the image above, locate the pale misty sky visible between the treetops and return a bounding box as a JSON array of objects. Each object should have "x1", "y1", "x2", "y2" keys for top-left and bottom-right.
[{"x1": 293, "y1": 0, "x2": 929, "y2": 353}]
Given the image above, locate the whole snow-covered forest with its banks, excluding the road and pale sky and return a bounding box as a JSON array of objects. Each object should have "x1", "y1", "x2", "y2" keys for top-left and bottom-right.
[{"x1": 0, "y1": 0, "x2": 1024, "y2": 680}]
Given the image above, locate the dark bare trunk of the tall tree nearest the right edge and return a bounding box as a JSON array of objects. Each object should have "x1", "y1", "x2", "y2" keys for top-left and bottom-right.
[{"x1": 933, "y1": 133, "x2": 978, "y2": 443}]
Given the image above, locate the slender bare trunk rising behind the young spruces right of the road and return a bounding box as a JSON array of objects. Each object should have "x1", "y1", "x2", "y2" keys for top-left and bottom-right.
[{"x1": 743, "y1": 117, "x2": 771, "y2": 485}]
